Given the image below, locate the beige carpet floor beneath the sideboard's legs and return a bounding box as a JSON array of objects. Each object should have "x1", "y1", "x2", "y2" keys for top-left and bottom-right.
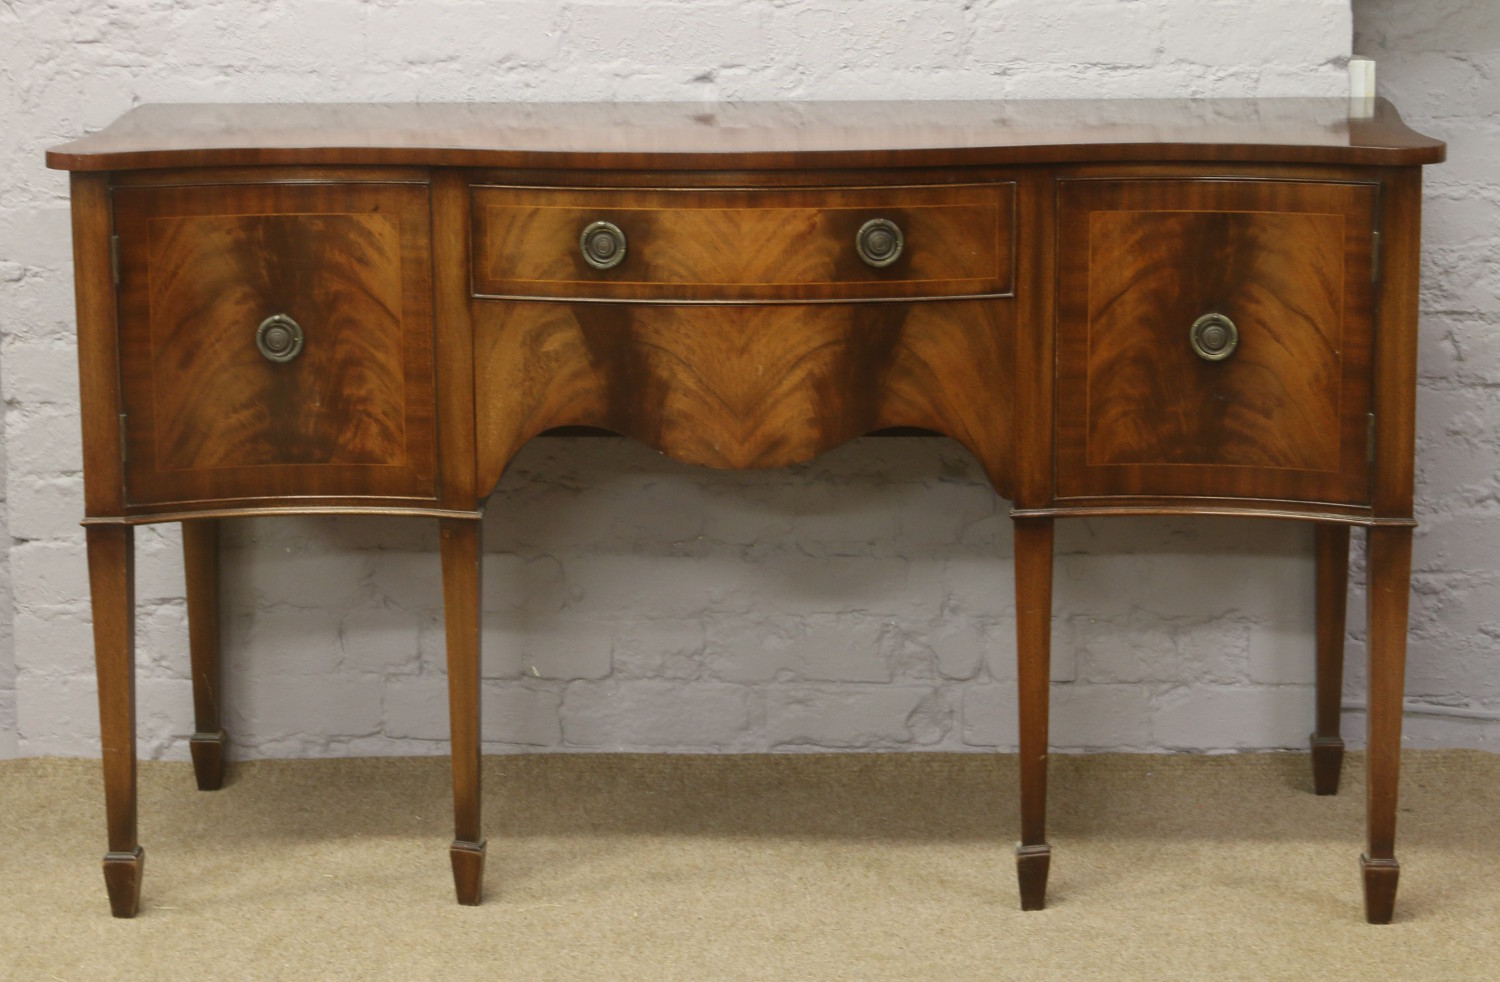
[{"x1": 0, "y1": 751, "x2": 1500, "y2": 982}]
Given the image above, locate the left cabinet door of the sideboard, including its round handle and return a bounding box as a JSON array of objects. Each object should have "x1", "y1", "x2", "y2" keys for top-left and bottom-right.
[{"x1": 116, "y1": 181, "x2": 437, "y2": 505}]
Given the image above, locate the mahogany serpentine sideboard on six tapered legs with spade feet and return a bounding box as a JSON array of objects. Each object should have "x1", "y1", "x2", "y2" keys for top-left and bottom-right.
[{"x1": 48, "y1": 99, "x2": 1445, "y2": 922}]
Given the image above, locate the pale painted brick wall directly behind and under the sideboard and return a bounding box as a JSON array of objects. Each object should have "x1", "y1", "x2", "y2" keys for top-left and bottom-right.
[{"x1": 14, "y1": 0, "x2": 1464, "y2": 757}]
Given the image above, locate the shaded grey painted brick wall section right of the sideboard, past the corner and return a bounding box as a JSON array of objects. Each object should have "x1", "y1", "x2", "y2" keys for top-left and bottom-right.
[{"x1": 1346, "y1": 0, "x2": 1500, "y2": 750}]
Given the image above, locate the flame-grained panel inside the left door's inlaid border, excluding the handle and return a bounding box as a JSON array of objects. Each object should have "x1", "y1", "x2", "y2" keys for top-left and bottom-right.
[{"x1": 150, "y1": 214, "x2": 407, "y2": 471}]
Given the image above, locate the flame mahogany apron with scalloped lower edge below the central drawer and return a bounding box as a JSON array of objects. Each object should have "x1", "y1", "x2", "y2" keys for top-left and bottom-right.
[{"x1": 474, "y1": 300, "x2": 1014, "y2": 495}]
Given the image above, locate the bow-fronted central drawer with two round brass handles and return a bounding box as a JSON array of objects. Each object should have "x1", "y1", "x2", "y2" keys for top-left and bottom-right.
[{"x1": 473, "y1": 183, "x2": 1016, "y2": 301}]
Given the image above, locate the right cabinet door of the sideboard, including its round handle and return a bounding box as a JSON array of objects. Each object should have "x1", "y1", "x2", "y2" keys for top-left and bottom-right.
[{"x1": 1058, "y1": 180, "x2": 1379, "y2": 504}]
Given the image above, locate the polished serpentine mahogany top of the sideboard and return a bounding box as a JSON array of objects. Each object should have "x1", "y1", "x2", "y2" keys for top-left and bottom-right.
[{"x1": 47, "y1": 99, "x2": 1445, "y2": 171}]
